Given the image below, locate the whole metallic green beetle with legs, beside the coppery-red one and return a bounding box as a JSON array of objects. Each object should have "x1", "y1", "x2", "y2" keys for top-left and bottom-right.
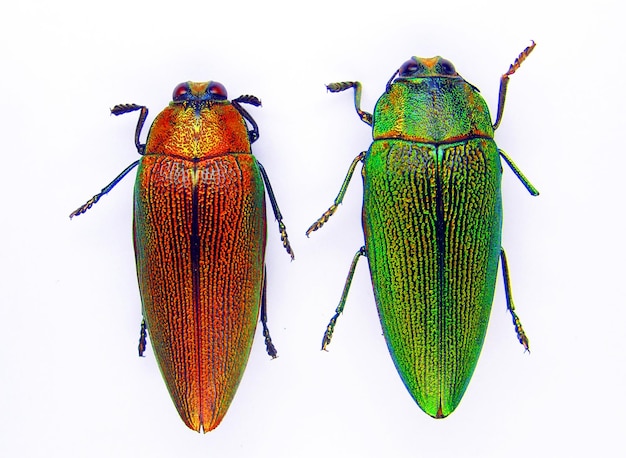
[{"x1": 307, "y1": 42, "x2": 539, "y2": 418}]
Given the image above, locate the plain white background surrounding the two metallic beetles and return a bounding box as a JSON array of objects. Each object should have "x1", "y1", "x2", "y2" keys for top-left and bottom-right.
[{"x1": 0, "y1": 0, "x2": 626, "y2": 458}]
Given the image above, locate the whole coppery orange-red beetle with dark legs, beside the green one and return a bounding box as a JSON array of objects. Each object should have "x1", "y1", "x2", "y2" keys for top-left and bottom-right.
[{"x1": 70, "y1": 81, "x2": 294, "y2": 432}]
